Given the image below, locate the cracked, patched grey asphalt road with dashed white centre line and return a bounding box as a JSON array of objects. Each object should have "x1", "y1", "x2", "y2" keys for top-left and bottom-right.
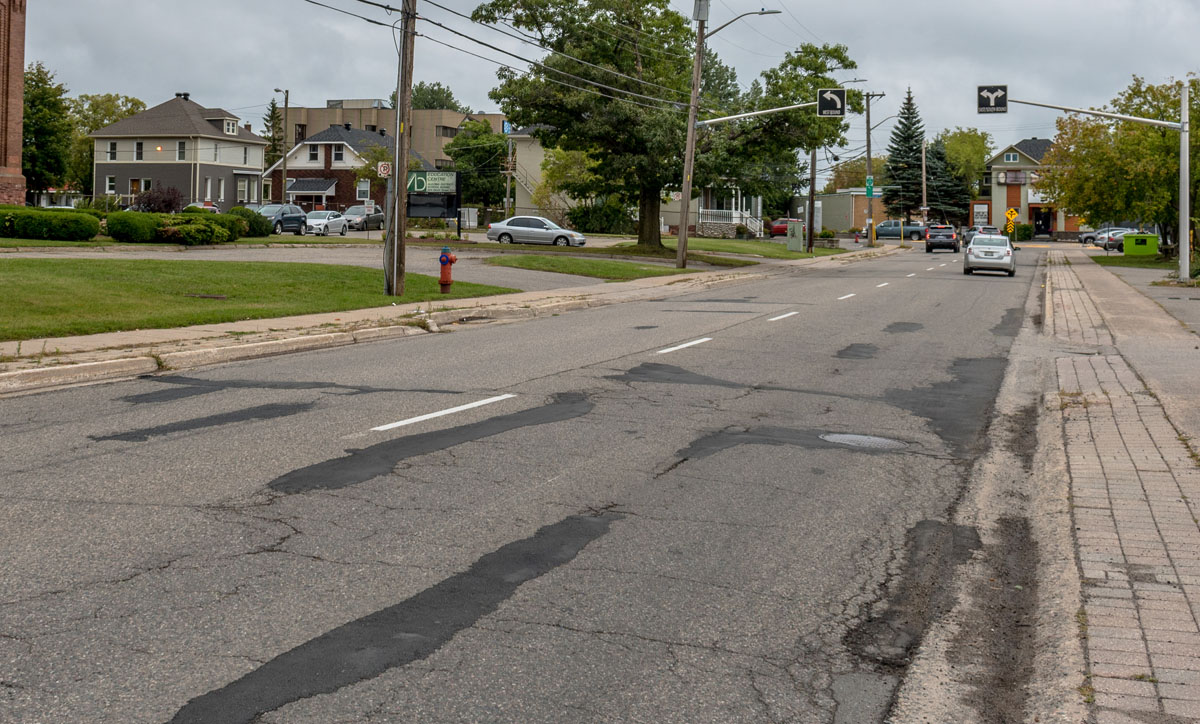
[{"x1": 0, "y1": 246, "x2": 1040, "y2": 724}]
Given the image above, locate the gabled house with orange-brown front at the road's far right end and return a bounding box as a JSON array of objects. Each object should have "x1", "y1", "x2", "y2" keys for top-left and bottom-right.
[{"x1": 971, "y1": 138, "x2": 1080, "y2": 239}]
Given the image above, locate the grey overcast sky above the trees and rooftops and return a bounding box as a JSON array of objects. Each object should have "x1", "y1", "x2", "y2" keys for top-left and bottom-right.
[{"x1": 25, "y1": 0, "x2": 1200, "y2": 180}]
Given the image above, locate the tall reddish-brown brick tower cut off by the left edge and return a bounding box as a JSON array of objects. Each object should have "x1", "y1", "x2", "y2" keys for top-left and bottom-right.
[{"x1": 0, "y1": 0, "x2": 25, "y2": 204}]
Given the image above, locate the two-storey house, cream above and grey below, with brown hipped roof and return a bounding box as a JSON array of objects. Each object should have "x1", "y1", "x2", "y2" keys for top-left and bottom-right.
[{"x1": 91, "y1": 92, "x2": 266, "y2": 209}]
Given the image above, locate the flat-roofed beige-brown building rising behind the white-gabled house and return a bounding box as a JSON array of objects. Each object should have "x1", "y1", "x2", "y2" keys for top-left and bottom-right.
[{"x1": 281, "y1": 98, "x2": 504, "y2": 168}]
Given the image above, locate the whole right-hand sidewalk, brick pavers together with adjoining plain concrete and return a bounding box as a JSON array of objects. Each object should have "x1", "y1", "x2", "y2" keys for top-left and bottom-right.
[{"x1": 1044, "y1": 250, "x2": 1200, "y2": 724}]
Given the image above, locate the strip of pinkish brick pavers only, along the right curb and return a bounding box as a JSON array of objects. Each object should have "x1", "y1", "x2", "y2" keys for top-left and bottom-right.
[{"x1": 1045, "y1": 252, "x2": 1200, "y2": 724}]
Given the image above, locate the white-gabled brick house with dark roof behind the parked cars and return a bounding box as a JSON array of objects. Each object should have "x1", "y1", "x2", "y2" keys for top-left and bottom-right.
[{"x1": 263, "y1": 124, "x2": 432, "y2": 211}]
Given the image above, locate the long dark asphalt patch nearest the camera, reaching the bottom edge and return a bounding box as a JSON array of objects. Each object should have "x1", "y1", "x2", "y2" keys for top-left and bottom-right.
[{"x1": 170, "y1": 515, "x2": 619, "y2": 724}]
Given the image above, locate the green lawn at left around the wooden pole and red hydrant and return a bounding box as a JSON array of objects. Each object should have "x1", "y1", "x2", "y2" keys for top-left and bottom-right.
[{"x1": 0, "y1": 257, "x2": 516, "y2": 340}]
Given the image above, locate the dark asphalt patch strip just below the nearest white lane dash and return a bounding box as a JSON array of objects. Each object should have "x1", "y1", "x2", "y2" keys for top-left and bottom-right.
[{"x1": 268, "y1": 393, "x2": 594, "y2": 493}]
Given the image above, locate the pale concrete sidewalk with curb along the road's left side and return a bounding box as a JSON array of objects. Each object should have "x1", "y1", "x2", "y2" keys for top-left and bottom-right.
[{"x1": 0, "y1": 246, "x2": 899, "y2": 394}]
